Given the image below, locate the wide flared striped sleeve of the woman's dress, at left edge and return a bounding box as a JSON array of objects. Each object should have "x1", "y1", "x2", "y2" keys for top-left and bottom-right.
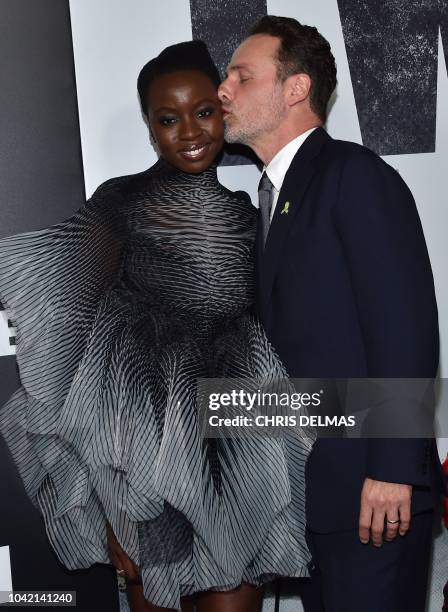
[{"x1": 0, "y1": 180, "x2": 124, "y2": 405}]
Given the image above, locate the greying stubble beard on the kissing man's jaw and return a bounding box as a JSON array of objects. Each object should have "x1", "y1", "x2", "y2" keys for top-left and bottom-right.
[{"x1": 224, "y1": 86, "x2": 287, "y2": 147}]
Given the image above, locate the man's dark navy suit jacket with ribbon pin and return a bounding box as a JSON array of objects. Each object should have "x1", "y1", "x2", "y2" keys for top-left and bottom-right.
[{"x1": 257, "y1": 128, "x2": 440, "y2": 533}]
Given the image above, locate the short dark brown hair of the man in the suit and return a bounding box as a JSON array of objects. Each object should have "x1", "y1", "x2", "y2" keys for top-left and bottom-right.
[{"x1": 250, "y1": 15, "x2": 337, "y2": 122}]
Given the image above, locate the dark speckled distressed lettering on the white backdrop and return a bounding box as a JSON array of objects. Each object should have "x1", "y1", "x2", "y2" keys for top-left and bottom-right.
[{"x1": 190, "y1": 0, "x2": 448, "y2": 155}]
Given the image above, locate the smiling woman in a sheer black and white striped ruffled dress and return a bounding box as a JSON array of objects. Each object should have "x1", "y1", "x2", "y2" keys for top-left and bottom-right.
[{"x1": 0, "y1": 42, "x2": 311, "y2": 612}]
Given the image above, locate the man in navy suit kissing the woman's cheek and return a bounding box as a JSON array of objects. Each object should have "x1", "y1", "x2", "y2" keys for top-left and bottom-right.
[{"x1": 219, "y1": 16, "x2": 438, "y2": 612}]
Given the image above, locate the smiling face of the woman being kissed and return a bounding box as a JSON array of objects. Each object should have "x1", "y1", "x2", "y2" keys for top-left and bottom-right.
[{"x1": 147, "y1": 70, "x2": 224, "y2": 174}]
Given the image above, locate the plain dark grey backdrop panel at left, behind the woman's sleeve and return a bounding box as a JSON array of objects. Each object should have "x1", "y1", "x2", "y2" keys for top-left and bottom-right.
[{"x1": 0, "y1": 0, "x2": 118, "y2": 612}]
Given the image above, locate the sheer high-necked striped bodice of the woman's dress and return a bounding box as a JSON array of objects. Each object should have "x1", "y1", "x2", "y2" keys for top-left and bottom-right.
[{"x1": 114, "y1": 161, "x2": 256, "y2": 319}]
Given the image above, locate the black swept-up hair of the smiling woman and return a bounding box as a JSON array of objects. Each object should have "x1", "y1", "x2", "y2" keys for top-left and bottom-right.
[{"x1": 137, "y1": 40, "x2": 221, "y2": 115}]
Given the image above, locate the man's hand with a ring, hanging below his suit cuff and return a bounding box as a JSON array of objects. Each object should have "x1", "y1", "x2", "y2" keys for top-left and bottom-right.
[{"x1": 359, "y1": 478, "x2": 412, "y2": 546}]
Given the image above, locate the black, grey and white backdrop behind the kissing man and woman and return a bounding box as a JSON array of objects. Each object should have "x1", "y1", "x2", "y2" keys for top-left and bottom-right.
[{"x1": 0, "y1": 0, "x2": 448, "y2": 612}]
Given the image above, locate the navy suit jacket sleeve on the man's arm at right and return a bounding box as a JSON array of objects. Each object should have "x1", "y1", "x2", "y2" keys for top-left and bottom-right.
[{"x1": 332, "y1": 148, "x2": 439, "y2": 485}]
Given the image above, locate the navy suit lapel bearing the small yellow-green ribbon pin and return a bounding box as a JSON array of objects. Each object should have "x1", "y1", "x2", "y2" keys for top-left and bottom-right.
[{"x1": 257, "y1": 128, "x2": 330, "y2": 304}]
